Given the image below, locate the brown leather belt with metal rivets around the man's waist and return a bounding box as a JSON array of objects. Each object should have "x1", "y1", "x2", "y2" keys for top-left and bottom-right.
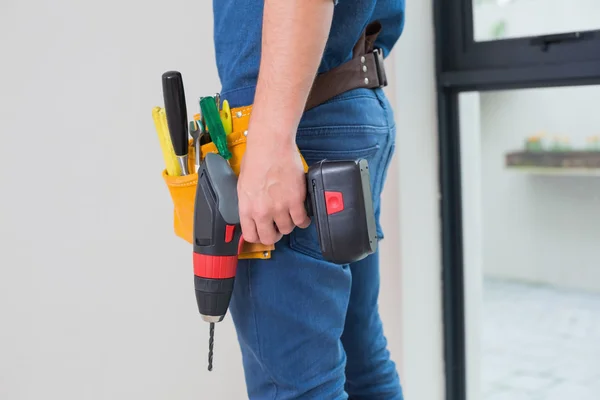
[{"x1": 304, "y1": 21, "x2": 387, "y2": 111}]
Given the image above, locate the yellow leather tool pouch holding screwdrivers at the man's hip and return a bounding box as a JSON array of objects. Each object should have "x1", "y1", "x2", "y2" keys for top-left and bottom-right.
[{"x1": 163, "y1": 106, "x2": 308, "y2": 259}]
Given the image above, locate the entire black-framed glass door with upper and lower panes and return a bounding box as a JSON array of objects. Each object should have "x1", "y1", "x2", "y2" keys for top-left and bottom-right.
[{"x1": 434, "y1": 0, "x2": 600, "y2": 400}]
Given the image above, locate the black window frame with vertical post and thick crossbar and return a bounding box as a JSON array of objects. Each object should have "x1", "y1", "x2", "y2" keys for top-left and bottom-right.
[{"x1": 433, "y1": 0, "x2": 600, "y2": 400}]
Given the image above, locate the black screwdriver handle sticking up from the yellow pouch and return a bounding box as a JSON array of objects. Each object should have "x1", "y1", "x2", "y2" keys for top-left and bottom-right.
[{"x1": 162, "y1": 71, "x2": 188, "y2": 157}]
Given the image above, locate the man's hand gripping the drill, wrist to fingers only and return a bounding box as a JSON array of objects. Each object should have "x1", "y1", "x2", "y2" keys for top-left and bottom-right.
[{"x1": 238, "y1": 138, "x2": 310, "y2": 245}]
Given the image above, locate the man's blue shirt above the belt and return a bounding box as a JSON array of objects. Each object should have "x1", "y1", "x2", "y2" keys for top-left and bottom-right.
[{"x1": 213, "y1": 0, "x2": 405, "y2": 107}]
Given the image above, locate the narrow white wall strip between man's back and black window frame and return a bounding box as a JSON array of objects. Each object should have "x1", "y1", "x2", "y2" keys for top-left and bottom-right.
[{"x1": 384, "y1": 1, "x2": 445, "y2": 400}]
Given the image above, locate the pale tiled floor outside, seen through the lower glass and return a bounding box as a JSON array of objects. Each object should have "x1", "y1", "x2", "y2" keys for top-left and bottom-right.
[{"x1": 481, "y1": 279, "x2": 600, "y2": 400}]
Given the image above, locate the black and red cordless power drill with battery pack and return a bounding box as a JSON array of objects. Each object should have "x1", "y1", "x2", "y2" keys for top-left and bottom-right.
[{"x1": 194, "y1": 153, "x2": 377, "y2": 371}]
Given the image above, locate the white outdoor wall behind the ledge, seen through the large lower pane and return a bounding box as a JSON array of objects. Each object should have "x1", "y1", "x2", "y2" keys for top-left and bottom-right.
[{"x1": 480, "y1": 86, "x2": 600, "y2": 290}]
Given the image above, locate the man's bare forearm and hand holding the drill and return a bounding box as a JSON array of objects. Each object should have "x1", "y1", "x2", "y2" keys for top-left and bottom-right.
[{"x1": 238, "y1": 0, "x2": 333, "y2": 244}]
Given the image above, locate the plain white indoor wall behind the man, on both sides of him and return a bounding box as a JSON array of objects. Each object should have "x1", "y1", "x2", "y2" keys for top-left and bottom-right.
[{"x1": 0, "y1": 0, "x2": 443, "y2": 400}]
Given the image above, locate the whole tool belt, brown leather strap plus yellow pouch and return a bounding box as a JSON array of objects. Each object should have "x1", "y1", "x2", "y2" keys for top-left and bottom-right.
[{"x1": 163, "y1": 22, "x2": 387, "y2": 259}]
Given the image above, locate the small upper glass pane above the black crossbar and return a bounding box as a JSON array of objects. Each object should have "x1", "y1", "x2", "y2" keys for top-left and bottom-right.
[{"x1": 472, "y1": 0, "x2": 600, "y2": 41}]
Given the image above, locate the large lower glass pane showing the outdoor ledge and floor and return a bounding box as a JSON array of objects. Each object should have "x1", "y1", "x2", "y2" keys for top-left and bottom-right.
[{"x1": 460, "y1": 86, "x2": 600, "y2": 400}]
